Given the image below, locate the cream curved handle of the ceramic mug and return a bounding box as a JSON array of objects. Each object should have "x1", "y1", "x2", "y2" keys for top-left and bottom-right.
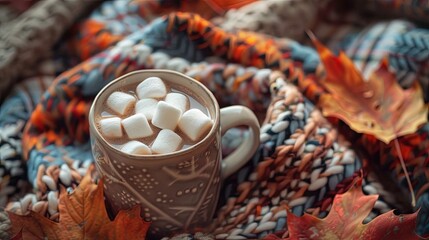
[{"x1": 220, "y1": 106, "x2": 260, "y2": 179}]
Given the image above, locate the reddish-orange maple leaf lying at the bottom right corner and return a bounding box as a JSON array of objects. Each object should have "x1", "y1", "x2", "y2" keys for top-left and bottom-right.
[{"x1": 287, "y1": 179, "x2": 420, "y2": 240}]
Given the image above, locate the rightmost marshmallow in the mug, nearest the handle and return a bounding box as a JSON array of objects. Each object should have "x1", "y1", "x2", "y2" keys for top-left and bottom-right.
[{"x1": 179, "y1": 108, "x2": 213, "y2": 141}]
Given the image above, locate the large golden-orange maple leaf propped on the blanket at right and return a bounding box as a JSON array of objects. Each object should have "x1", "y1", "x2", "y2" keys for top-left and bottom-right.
[{"x1": 309, "y1": 34, "x2": 428, "y2": 144}]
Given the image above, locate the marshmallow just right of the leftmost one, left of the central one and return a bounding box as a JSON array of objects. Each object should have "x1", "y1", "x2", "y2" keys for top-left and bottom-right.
[{"x1": 122, "y1": 113, "x2": 153, "y2": 139}]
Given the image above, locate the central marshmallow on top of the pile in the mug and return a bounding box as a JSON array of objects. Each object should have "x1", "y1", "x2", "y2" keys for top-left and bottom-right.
[{"x1": 152, "y1": 101, "x2": 182, "y2": 130}]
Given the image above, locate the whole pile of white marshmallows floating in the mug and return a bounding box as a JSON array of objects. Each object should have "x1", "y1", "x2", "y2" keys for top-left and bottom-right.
[{"x1": 99, "y1": 77, "x2": 213, "y2": 155}]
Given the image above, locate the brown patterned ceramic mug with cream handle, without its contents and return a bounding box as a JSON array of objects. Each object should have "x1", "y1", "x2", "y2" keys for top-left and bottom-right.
[{"x1": 89, "y1": 70, "x2": 259, "y2": 235}]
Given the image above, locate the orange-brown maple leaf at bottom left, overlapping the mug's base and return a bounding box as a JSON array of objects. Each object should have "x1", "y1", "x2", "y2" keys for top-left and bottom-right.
[{"x1": 9, "y1": 174, "x2": 149, "y2": 240}]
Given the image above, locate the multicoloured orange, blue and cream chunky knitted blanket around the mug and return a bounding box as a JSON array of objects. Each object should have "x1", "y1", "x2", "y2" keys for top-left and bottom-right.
[{"x1": 0, "y1": 0, "x2": 429, "y2": 239}]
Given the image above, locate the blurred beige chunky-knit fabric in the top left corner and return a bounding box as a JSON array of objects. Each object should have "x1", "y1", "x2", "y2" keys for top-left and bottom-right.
[{"x1": 0, "y1": 0, "x2": 97, "y2": 99}]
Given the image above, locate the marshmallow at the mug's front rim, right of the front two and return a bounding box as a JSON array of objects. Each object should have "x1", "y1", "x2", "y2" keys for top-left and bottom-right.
[{"x1": 152, "y1": 129, "x2": 182, "y2": 154}]
